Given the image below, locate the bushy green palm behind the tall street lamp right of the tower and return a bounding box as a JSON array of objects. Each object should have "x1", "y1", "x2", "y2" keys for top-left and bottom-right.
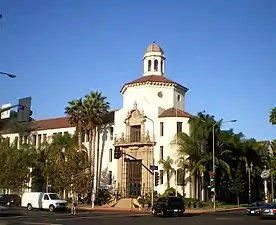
[{"x1": 178, "y1": 112, "x2": 231, "y2": 198}]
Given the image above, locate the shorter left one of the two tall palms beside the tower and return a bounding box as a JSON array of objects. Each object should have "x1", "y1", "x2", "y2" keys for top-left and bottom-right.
[{"x1": 65, "y1": 98, "x2": 84, "y2": 149}]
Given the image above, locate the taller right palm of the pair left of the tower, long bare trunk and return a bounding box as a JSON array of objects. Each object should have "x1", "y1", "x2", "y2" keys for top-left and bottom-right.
[{"x1": 83, "y1": 91, "x2": 110, "y2": 202}]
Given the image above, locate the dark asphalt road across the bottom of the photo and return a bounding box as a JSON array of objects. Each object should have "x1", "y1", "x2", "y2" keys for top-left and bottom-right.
[{"x1": 0, "y1": 211, "x2": 275, "y2": 225}]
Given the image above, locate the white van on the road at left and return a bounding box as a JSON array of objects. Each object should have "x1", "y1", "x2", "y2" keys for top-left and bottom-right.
[{"x1": 21, "y1": 192, "x2": 67, "y2": 212}]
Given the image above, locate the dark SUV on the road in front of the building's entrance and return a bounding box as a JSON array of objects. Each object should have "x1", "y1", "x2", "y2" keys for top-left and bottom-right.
[{"x1": 152, "y1": 196, "x2": 185, "y2": 216}]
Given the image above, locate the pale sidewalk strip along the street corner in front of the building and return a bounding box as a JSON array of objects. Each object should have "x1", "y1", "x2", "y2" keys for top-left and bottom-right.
[{"x1": 74, "y1": 205, "x2": 245, "y2": 214}]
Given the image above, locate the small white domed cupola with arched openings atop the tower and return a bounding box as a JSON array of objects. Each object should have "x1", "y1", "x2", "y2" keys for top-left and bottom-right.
[{"x1": 143, "y1": 41, "x2": 166, "y2": 76}]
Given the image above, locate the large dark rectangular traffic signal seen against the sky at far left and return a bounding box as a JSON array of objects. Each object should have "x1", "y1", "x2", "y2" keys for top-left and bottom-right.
[{"x1": 17, "y1": 97, "x2": 32, "y2": 123}]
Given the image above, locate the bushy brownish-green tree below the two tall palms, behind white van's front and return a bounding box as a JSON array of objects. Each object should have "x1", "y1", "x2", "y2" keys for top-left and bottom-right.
[{"x1": 44, "y1": 134, "x2": 90, "y2": 197}]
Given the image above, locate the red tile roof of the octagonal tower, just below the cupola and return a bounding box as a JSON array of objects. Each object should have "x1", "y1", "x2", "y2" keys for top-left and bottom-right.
[{"x1": 120, "y1": 75, "x2": 188, "y2": 92}]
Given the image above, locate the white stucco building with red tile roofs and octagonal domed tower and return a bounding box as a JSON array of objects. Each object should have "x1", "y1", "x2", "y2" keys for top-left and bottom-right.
[{"x1": 2, "y1": 42, "x2": 195, "y2": 197}]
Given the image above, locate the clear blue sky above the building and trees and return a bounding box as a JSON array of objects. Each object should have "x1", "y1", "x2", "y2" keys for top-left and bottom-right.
[{"x1": 0, "y1": 0, "x2": 276, "y2": 139}]
